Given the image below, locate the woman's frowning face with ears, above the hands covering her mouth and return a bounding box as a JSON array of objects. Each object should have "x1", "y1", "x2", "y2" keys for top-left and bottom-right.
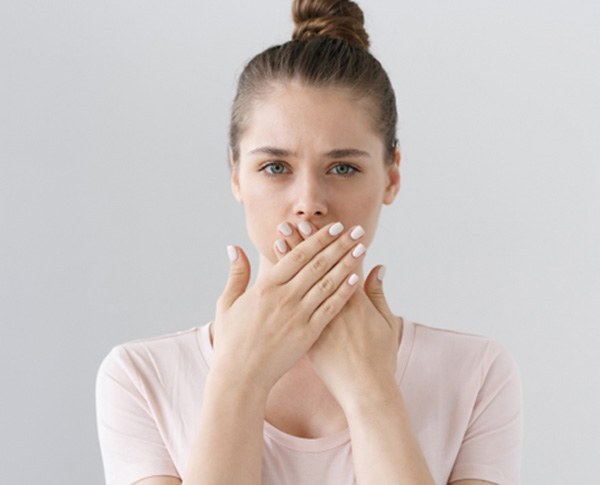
[{"x1": 231, "y1": 83, "x2": 400, "y2": 268}]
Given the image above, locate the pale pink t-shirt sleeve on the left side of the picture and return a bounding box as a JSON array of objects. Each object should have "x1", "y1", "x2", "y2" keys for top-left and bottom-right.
[{"x1": 96, "y1": 346, "x2": 179, "y2": 485}]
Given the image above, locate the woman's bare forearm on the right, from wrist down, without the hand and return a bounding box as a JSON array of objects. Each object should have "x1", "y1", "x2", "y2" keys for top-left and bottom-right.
[{"x1": 344, "y1": 381, "x2": 434, "y2": 485}]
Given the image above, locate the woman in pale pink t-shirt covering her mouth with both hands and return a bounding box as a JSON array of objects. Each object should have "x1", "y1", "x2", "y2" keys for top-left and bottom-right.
[{"x1": 97, "y1": 0, "x2": 521, "y2": 485}]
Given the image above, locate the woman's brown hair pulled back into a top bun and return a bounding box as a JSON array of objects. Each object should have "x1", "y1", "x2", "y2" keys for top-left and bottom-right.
[{"x1": 229, "y1": 0, "x2": 398, "y2": 164}]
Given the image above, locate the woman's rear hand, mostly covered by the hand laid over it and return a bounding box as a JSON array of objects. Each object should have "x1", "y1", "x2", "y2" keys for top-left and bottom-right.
[{"x1": 277, "y1": 223, "x2": 402, "y2": 409}]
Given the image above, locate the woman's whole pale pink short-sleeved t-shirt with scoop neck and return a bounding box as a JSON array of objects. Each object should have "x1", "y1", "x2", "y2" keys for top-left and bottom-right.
[{"x1": 96, "y1": 319, "x2": 521, "y2": 485}]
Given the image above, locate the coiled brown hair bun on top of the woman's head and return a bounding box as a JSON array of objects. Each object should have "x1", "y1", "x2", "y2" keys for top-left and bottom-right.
[{"x1": 292, "y1": 0, "x2": 369, "y2": 50}]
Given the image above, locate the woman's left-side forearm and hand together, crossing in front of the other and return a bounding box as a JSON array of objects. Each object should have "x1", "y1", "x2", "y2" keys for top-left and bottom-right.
[{"x1": 183, "y1": 224, "x2": 362, "y2": 485}]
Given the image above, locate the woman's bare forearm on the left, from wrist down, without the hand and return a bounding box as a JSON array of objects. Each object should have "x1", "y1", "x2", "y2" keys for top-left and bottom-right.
[{"x1": 183, "y1": 369, "x2": 267, "y2": 485}]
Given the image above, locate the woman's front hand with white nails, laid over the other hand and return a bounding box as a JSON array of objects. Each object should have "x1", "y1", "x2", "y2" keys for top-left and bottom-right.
[{"x1": 213, "y1": 223, "x2": 370, "y2": 395}]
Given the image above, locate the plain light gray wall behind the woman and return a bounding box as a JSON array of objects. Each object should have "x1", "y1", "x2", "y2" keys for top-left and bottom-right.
[{"x1": 0, "y1": 0, "x2": 600, "y2": 484}]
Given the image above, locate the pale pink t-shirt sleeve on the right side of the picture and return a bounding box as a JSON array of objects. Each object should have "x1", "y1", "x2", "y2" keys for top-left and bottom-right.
[{"x1": 450, "y1": 342, "x2": 522, "y2": 485}]
